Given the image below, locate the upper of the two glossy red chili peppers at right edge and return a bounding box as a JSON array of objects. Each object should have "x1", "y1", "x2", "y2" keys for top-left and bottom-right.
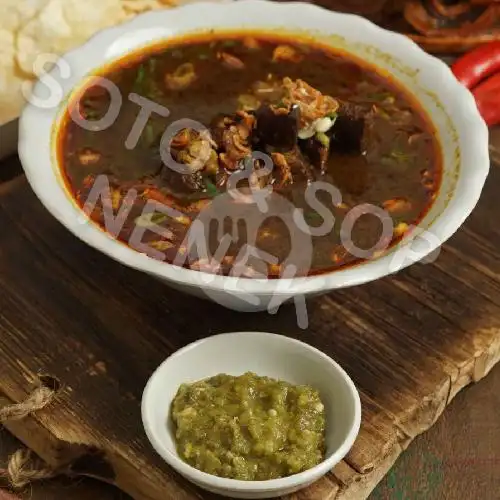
[{"x1": 451, "y1": 41, "x2": 500, "y2": 89}]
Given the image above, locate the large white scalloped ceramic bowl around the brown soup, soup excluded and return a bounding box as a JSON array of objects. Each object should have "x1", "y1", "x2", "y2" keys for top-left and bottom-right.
[{"x1": 19, "y1": 0, "x2": 489, "y2": 310}]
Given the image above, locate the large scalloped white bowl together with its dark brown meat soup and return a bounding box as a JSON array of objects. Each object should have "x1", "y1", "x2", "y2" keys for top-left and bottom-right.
[{"x1": 19, "y1": 0, "x2": 489, "y2": 311}]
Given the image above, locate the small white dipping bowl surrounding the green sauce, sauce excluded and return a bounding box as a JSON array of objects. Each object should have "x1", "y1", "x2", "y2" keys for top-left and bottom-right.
[{"x1": 142, "y1": 332, "x2": 361, "y2": 498}]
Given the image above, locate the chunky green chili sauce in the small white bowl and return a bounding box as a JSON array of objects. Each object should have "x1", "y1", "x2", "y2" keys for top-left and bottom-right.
[{"x1": 171, "y1": 373, "x2": 326, "y2": 481}]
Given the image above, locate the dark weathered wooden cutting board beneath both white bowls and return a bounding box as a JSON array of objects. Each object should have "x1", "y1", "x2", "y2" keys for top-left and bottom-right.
[{"x1": 0, "y1": 145, "x2": 500, "y2": 500}]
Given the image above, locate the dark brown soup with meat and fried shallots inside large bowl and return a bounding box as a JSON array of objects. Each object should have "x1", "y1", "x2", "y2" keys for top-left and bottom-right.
[{"x1": 58, "y1": 33, "x2": 442, "y2": 277}]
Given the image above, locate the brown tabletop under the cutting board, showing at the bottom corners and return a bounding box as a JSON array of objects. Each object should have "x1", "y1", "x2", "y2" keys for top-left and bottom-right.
[{"x1": 0, "y1": 360, "x2": 500, "y2": 500}]
